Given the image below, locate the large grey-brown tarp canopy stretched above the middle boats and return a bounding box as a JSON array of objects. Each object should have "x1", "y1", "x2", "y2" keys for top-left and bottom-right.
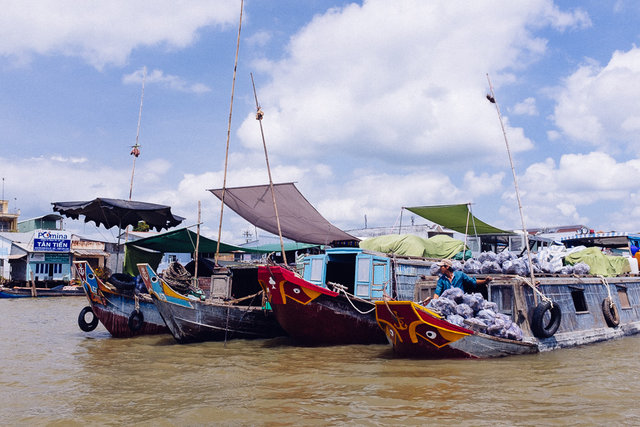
[{"x1": 209, "y1": 183, "x2": 358, "y2": 245}]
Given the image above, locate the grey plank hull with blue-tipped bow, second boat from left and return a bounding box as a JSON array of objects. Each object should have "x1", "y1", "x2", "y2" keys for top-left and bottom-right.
[{"x1": 138, "y1": 264, "x2": 285, "y2": 343}]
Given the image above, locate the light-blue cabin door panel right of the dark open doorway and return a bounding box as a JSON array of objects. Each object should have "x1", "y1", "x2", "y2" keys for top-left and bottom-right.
[{"x1": 354, "y1": 254, "x2": 391, "y2": 300}]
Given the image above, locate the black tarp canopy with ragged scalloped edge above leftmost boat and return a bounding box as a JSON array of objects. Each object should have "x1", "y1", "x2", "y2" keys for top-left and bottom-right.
[{"x1": 52, "y1": 198, "x2": 184, "y2": 231}]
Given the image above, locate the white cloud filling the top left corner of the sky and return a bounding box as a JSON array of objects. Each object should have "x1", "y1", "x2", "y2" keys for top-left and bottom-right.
[{"x1": 0, "y1": 0, "x2": 238, "y2": 69}]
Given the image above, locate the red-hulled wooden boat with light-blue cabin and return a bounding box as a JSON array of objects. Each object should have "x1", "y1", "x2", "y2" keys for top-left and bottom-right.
[{"x1": 258, "y1": 248, "x2": 433, "y2": 345}]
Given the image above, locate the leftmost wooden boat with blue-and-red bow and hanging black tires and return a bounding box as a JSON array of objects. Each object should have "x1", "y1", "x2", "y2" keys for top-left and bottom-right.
[{"x1": 73, "y1": 261, "x2": 169, "y2": 338}]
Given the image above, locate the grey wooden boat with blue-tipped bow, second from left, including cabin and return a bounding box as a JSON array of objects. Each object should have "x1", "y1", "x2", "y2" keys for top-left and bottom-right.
[{"x1": 138, "y1": 264, "x2": 285, "y2": 343}]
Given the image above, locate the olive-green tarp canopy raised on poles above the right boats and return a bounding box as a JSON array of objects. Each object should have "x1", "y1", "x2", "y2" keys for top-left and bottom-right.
[{"x1": 404, "y1": 204, "x2": 512, "y2": 235}]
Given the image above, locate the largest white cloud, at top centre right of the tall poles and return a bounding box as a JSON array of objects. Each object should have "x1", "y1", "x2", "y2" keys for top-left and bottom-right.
[{"x1": 239, "y1": 0, "x2": 588, "y2": 171}]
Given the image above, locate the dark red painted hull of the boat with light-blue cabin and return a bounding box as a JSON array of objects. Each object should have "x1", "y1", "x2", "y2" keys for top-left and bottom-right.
[{"x1": 258, "y1": 266, "x2": 386, "y2": 345}]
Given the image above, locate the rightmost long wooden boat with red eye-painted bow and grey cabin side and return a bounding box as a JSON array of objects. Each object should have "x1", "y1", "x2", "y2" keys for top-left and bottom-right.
[{"x1": 376, "y1": 275, "x2": 640, "y2": 359}]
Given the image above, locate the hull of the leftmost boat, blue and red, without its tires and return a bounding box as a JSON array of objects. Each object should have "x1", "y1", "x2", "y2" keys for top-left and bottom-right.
[{"x1": 74, "y1": 261, "x2": 169, "y2": 338}]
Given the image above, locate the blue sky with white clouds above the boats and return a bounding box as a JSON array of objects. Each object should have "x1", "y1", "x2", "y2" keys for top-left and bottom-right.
[{"x1": 0, "y1": 0, "x2": 640, "y2": 244}]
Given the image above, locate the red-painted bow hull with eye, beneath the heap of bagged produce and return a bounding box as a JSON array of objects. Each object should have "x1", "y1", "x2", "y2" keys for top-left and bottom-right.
[{"x1": 376, "y1": 301, "x2": 539, "y2": 359}]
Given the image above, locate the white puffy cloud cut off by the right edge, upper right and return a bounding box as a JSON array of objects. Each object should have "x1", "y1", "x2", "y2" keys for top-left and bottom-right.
[{"x1": 554, "y1": 47, "x2": 640, "y2": 155}]
